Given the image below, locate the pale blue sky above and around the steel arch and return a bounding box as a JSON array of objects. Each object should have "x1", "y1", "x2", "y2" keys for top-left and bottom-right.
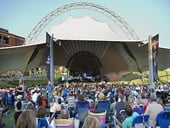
[{"x1": 0, "y1": 0, "x2": 170, "y2": 48}]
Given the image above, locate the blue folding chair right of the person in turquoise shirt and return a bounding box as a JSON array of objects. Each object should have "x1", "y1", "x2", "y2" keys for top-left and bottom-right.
[{"x1": 132, "y1": 115, "x2": 150, "y2": 128}]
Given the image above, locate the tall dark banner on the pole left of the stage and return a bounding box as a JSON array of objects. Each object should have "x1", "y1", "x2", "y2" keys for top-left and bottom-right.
[{"x1": 46, "y1": 32, "x2": 51, "y2": 81}]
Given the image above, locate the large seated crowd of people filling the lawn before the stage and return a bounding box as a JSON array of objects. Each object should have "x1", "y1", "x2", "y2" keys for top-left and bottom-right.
[{"x1": 0, "y1": 80, "x2": 170, "y2": 128}]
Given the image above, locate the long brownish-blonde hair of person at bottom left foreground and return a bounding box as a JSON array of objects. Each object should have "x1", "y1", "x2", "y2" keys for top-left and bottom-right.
[{"x1": 16, "y1": 109, "x2": 36, "y2": 128}]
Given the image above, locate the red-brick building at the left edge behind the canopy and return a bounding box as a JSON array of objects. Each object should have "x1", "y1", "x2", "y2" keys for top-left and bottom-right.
[{"x1": 0, "y1": 28, "x2": 25, "y2": 47}]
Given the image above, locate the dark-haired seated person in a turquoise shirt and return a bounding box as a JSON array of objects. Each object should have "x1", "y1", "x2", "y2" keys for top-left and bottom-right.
[{"x1": 114, "y1": 104, "x2": 139, "y2": 128}]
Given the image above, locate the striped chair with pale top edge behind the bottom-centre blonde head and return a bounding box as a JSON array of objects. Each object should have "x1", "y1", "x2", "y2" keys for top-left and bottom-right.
[{"x1": 88, "y1": 111, "x2": 106, "y2": 128}]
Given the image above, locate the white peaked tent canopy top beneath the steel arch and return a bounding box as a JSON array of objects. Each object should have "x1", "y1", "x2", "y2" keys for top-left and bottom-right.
[{"x1": 49, "y1": 16, "x2": 133, "y2": 41}]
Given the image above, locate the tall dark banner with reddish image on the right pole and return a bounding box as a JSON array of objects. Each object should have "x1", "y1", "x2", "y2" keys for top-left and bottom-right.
[{"x1": 152, "y1": 34, "x2": 159, "y2": 81}]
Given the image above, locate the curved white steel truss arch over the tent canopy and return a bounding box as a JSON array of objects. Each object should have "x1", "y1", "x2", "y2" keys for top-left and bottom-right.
[{"x1": 26, "y1": 2, "x2": 139, "y2": 43}]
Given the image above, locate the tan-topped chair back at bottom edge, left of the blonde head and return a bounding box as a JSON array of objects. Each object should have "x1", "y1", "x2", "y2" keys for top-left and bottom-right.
[{"x1": 55, "y1": 119, "x2": 74, "y2": 128}]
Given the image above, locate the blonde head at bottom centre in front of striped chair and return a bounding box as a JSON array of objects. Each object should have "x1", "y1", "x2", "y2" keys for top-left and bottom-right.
[{"x1": 82, "y1": 116, "x2": 100, "y2": 128}]
